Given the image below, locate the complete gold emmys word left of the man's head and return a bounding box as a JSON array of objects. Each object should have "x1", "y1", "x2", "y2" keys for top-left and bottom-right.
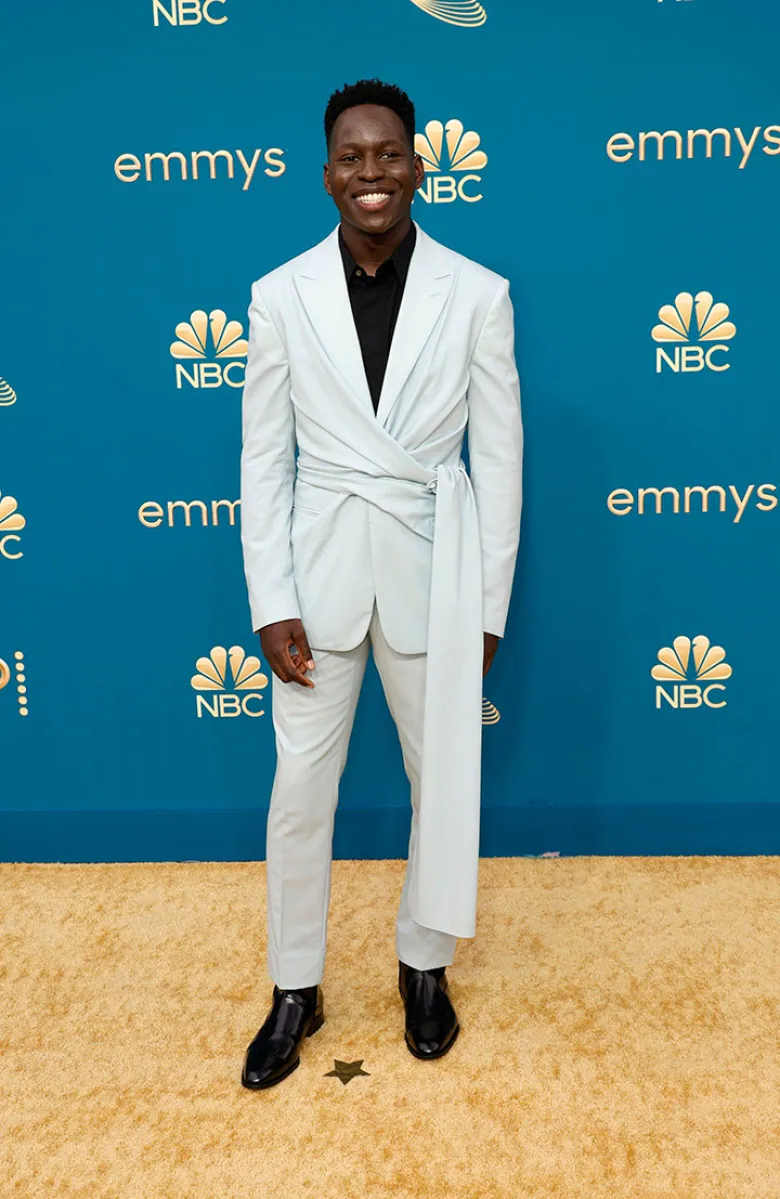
[{"x1": 114, "y1": 146, "x2": 288, "y2": 192}]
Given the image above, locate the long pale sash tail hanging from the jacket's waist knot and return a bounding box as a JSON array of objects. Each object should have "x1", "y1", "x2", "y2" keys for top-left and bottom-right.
[{"x1": 410, "y1": 464, "x2": 484, "y2": 936}]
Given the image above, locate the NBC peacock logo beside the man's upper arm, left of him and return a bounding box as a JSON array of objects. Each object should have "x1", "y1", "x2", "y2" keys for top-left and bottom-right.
[{"x1": 170, "y1": 308, "x2": 249, "y2": 388}]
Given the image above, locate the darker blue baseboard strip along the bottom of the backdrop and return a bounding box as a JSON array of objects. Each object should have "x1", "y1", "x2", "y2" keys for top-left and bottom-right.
[{"x1": 0, "y1": 803, "x2": 780, "y2": 862}]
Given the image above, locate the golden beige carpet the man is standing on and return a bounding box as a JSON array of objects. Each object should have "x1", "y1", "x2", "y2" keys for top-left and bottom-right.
[{"x1": 0, "y1": 858, "x2": 780, "y2": 1199}]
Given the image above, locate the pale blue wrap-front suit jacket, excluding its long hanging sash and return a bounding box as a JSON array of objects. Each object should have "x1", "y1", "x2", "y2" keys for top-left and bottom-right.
[{"x1": 241, "y1": 220, "x2": 522, "y2": 653}]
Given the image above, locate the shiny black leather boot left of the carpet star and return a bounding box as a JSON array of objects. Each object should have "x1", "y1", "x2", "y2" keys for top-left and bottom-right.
[{"x1": 241, "y1": 987, "x2": 325, "y2": 1091}]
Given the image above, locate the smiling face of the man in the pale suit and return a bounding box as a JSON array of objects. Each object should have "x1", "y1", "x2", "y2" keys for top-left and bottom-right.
[{"x1": 325, "y1": 104, "x2": 424, "y2": 235}]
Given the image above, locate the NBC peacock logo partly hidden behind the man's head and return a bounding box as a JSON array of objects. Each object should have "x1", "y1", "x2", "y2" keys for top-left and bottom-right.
[{"x1": 415, "y1": 120, "x2": 488, "y2": 204}]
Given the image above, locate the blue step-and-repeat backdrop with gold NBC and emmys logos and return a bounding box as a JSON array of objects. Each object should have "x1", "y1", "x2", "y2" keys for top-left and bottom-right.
[{"x1": 0, "y1": 0, "x2": 780, "y2": 861}]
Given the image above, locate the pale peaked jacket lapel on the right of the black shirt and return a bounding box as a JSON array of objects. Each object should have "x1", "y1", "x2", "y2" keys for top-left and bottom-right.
[{"x1": 376, "y1": 222, "x2": 454, "y2": 424}]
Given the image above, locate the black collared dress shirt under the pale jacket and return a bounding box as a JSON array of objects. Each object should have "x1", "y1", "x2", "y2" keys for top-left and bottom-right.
[{"x1": 339, "y1": 222, "x2": 417, "y2": 411}]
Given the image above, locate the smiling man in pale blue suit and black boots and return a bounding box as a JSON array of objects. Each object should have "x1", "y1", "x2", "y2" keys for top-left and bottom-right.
[{"x1": 241, "y1": 72, "x2": 522, "y2": 1089}]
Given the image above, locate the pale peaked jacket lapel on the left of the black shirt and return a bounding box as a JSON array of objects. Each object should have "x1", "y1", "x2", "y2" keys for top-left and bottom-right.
[{"x1": 294, "y1": 227, "x2": 376, "y2": 415}]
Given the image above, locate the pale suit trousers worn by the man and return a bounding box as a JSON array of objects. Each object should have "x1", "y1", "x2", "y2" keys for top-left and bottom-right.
[{"x1": 266, "y1": 607, "x2": 456, "y2": 989}]
